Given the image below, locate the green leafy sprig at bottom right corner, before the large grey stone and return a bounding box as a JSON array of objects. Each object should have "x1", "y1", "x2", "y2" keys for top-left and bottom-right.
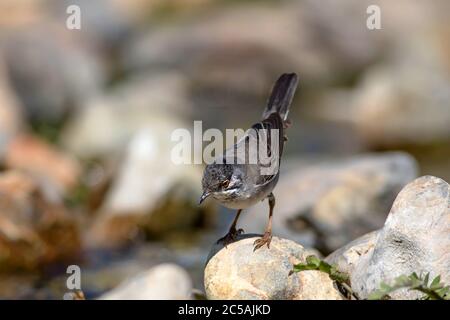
[{"x1": 369, "y1": 272, "x2": 450, "y2": 300}]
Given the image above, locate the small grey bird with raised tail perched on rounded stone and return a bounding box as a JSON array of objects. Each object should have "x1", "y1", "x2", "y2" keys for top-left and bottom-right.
[{"x1": 199, "y1": 73, "x2": 298, "y2": 251}]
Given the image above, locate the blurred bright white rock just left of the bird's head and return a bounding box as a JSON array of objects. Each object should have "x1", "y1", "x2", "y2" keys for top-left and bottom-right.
[{"x1": 103, "y1": 123, "x2": 201, "y2": 213}]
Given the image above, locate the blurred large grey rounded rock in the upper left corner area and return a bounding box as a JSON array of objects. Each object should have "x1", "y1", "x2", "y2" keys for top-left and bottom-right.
[{"x1": 0, "y1": 23, "x2": 105, "y2": 123}]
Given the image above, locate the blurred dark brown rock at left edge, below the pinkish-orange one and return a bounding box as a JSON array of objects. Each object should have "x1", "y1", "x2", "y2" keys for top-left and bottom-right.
[{"x1": 0, "y1": 171, "x2": 80, "y2": 271}]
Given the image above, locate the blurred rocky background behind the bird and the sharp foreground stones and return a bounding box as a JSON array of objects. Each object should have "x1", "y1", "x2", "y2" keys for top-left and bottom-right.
[{"x1": 0, "y1": 0, "x2": 450, "y2": 299}]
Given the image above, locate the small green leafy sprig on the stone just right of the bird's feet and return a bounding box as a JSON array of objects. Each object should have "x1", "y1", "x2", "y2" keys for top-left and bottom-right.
[{"x1": 290, "y1": 255, "x2": 359, "y2": 299}]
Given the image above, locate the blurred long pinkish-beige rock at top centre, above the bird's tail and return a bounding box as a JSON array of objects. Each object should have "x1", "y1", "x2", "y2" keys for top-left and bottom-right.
[{"x1": 123, "y1": 4, "x2": 318, "y2": 77}]
